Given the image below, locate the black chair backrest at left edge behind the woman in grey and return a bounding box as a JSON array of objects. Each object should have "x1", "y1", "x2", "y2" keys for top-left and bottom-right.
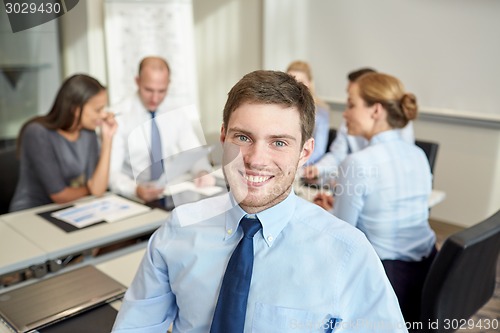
[{"x1": 0, "y1": 147, "x2": 19, "y2": 214}]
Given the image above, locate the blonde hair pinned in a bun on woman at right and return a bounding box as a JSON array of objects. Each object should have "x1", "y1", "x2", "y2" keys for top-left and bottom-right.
[{"x1": 356, "y1": 73, "x2": 418, "y2": 128}]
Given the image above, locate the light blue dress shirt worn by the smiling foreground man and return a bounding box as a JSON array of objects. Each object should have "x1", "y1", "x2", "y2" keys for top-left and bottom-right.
[{"x1": 113, "y1": 192, "x2": 407, "y2": 333}]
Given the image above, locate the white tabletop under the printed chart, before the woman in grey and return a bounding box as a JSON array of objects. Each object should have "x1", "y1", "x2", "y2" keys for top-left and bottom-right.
[{"x1": 0, "y1": 193, "x2": 170, "y2": 276}]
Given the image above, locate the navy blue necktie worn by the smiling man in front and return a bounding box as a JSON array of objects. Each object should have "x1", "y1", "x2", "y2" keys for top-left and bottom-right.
[{"x1": 210, "y1": 217, "x2": 262, "y2": 333}]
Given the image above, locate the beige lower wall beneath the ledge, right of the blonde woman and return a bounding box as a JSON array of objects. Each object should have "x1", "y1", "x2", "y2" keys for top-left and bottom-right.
[{"x1": 415, "y1": 116, "x2": 500, "y2": 226}]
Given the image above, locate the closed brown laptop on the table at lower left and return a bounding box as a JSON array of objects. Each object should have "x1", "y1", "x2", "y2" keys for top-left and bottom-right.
[{"x1": 0, "y1": 266, "x2": 127, "y2": 333}]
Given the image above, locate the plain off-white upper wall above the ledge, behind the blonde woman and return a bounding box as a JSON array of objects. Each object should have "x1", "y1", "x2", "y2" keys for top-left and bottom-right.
[{"x1": 264, "y1": 0, "x2": 500, "y2": 122}]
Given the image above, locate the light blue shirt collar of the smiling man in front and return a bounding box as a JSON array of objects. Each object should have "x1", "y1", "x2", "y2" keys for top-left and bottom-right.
[{"x1": 224, "y1": 190, "x2": 297, "y2": 246}]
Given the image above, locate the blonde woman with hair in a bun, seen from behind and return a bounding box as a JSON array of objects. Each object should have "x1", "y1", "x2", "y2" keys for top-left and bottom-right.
[{"x1": 316, "y1": 73, "x2": 436, "y2": 321}]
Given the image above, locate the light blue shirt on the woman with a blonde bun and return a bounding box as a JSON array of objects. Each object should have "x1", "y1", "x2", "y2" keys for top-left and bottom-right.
[{"x1": 333, "y1": 130, "x2": 436, "y2": 261}]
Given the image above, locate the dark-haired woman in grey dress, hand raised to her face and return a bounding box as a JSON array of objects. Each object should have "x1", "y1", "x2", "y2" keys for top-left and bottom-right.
[{"x1": 10, "y1": 74, "x2": 117, "y2": 211}]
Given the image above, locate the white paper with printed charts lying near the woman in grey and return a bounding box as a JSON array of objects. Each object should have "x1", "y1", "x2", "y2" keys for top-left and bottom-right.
[{"x1": 51, "y1": 196, "x2": 151, "y2": 228}]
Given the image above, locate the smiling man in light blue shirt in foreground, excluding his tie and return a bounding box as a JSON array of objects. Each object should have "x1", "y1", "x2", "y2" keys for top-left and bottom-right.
[{"x1": 114, "y1": 71, "x2": 407, "y2": 333}]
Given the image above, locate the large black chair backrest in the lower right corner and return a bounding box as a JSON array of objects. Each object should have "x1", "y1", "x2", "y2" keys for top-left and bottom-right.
[{"x1": 422, "y1": 210, "x2": 500, "y2": 332}]
